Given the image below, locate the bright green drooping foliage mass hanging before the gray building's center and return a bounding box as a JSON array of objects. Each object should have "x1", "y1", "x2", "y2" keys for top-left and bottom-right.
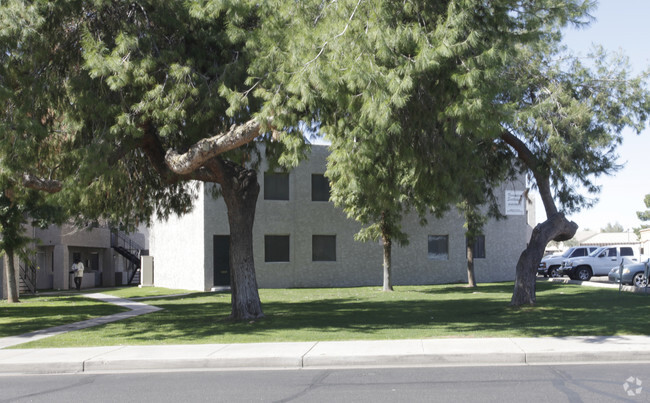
[{"x1": 270, "y1": 0, "x2": 592, "y2": 296}]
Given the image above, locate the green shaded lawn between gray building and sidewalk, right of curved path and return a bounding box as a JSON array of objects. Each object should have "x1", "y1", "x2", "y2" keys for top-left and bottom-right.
[{"x1": 7, "y1": 283, "x2": 650, "y2": 348}]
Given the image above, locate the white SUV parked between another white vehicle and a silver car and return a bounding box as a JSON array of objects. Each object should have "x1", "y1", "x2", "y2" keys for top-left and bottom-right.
[{"x1": 558, "y1": 246, "x2": 639, "y2": 281}]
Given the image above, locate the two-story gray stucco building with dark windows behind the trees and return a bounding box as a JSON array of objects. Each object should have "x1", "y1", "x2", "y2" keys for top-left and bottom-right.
[{"x1": 149, "y1": 146, "x2": 535, "y2": 291}]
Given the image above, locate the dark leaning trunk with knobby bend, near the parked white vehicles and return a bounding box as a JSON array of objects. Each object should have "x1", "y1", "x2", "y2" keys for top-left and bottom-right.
[{"x1": 510, "y1": 213, "x2": 578, "y2": 306}]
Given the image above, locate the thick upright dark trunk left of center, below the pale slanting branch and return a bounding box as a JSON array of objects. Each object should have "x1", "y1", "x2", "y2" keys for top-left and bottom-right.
[{"x1": 215, "y1": 161, "x2": 264, "y2": 320}]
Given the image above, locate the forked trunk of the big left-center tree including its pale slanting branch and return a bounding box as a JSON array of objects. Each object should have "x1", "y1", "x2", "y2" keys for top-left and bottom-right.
[{"x1": 140, "y1": 126, "x2": 264, "y2": 320}]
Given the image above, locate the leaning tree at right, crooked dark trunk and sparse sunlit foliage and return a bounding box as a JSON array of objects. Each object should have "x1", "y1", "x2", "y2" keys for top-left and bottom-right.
[{"x1": 499, "y1": 41, "x2": 650, "y2": 306}]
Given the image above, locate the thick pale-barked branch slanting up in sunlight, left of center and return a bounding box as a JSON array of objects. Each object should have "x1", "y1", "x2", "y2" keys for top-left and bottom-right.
[{"x1": 165, "y1": 119, "x2": 260, "y2": 175}]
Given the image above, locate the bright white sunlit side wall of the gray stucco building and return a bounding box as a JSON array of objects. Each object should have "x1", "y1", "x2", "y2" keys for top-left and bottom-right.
[{"x1": 149, "y1": 186, "x2": 205, "y2": 291}]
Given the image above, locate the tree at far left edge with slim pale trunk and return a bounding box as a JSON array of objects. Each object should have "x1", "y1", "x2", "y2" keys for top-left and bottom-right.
[{"x1": 0, "y1": 9, "x2": 66, "y2": 303}]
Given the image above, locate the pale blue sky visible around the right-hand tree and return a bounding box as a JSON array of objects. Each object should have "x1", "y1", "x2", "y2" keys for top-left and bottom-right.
[{"x1": 536, "y1": 0, "x2": 650, "y2": 231}]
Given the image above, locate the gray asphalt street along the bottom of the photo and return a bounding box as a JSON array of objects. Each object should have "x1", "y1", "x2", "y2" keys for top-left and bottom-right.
[{"x1": 0, "y1": 364, "x2": 650, "y2": 403}]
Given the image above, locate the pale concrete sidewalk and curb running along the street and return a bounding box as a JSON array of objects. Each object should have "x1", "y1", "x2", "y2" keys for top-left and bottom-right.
[{"x1": 0, "y1": 336, "x2": 650, "y2": 374}]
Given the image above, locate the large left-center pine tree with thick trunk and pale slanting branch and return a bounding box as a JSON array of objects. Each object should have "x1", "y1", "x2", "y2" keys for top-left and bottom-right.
[{"x1": 0, "y1": 0, "x2": 304, "y2": 319}]
